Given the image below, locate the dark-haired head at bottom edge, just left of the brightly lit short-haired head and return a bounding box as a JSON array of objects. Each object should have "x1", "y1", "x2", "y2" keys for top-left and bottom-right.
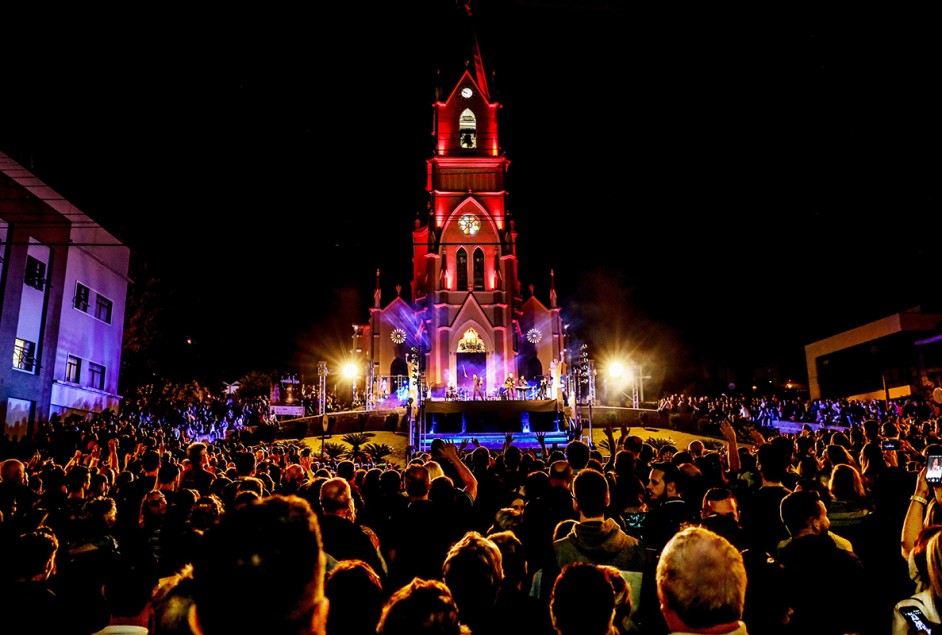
[{"x1": 550, "y1": 562, "x2": 617, "y2": 635}]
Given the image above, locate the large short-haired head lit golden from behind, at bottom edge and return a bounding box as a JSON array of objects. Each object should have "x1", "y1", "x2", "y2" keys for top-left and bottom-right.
[{"x1": 656, "y1": 526, "x2": 752, "y2": 635}]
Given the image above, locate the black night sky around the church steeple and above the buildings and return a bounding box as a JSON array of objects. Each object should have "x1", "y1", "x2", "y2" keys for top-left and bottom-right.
[{"x1": 0, "y1": 0, "x2": 942, "y2": 387}]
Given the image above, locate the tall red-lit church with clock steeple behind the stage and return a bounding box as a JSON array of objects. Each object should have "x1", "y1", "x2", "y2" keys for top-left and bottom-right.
[{"x1": 354, "y1": 44, "x2": 566, "y2": 407}]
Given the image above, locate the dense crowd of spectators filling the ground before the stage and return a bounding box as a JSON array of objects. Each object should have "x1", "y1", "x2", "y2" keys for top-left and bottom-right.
[{"x1": 0, "y1": 396, "x2": 942, "y2": 635}]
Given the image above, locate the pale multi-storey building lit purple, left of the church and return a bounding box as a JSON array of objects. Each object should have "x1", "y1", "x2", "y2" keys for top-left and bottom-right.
[{"x1": 0, "y1": 153, "x2": 130, "y2": 438}]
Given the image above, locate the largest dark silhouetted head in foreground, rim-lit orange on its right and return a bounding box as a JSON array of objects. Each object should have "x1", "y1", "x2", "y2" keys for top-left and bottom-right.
[{"x1": 193, "y1": 494, "x2": 329, "y2": 635}]
